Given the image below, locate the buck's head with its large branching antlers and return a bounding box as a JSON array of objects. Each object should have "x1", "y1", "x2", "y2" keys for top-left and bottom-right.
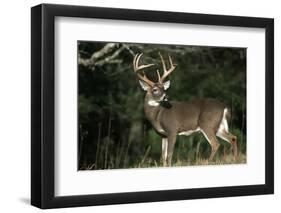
[{"x1": 133, "y1": 53, "x2": 176, "y2": 106}]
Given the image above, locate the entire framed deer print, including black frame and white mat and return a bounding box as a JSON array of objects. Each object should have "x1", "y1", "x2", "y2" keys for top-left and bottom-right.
[{"x1": 31, "y1": 4, "x2": 274, "y2": 209}]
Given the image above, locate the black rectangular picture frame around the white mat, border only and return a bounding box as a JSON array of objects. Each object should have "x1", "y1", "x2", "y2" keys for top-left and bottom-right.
[{"x1": 31, "y1": 4, "x2": 274, "y2": 209}]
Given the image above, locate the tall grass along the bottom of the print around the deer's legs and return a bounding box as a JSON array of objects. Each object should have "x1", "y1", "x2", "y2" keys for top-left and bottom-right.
[{"x1": 79, "y1": 122, "x2": 246, "y2": 170}]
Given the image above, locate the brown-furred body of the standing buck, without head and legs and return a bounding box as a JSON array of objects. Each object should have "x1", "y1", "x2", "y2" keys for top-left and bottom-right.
[{"x1": 144, "y1": 97, "x2": 225, "y2": 136}]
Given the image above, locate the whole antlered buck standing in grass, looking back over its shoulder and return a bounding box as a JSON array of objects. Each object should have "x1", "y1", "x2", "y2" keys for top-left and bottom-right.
[{"x1": 133, "y1": 53, "x2": 237, "y2": 166}]
